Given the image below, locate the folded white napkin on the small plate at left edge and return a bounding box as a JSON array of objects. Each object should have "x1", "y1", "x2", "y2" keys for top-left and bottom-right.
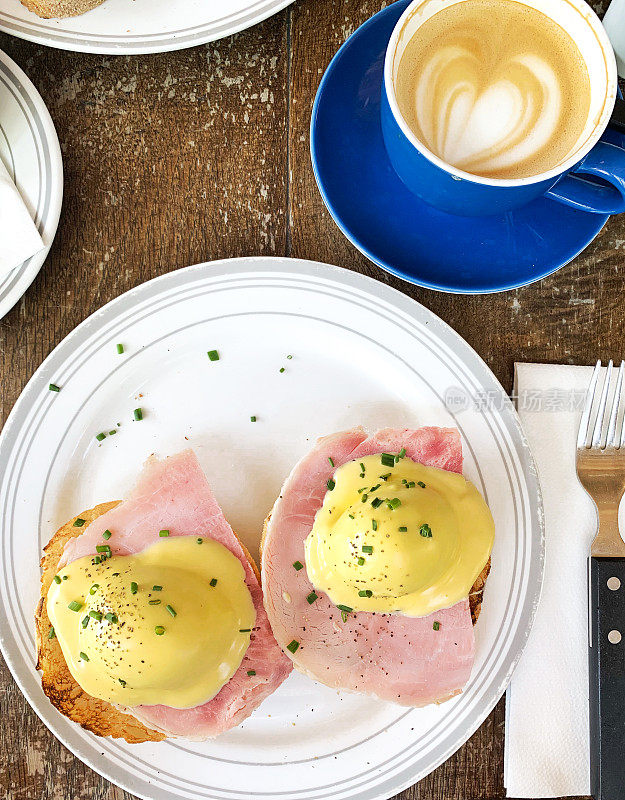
[{"x1": 0, "y1": 159, "x2": 44, "y2": 280}]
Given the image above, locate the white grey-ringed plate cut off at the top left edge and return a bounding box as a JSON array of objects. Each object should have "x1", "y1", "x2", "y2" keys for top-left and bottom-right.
[{"x1": 0, "y1": 0, "x2": 293, "y2": 55}]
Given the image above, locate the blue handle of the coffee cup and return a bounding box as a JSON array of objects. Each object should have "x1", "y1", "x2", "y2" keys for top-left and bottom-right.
[{"x1": 545, "y1": 142, "x2": 625, "y2": 214}]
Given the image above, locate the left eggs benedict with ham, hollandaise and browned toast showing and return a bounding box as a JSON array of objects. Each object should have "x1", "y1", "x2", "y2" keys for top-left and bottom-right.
[{"x1": 36, "y1": 451, "x2": 290, "y2": 742}]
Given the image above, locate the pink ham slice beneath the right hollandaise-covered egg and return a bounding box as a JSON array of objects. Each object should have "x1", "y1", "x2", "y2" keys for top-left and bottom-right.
[{"x1": 262, "y1": 428, "x2": 474, "y2": 706}]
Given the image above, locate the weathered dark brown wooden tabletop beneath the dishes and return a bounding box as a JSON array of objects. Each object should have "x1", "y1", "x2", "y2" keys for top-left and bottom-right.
[{"x1": 0, "y1": 0, "x2": 625, "y2": 800}]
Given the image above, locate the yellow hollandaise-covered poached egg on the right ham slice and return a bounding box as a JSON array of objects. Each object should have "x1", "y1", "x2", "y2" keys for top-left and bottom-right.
[{"x1": 305, "y1": 452, "x2": 495, "y2": 617}]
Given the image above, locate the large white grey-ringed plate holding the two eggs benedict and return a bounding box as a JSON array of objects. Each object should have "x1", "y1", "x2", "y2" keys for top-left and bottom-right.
[{"x1": 0, "y1": 258, "x2": 543, "y2": 800}]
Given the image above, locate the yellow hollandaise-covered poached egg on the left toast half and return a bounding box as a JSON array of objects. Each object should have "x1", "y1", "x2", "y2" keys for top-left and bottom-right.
[{"x1": 47, "y1": 533, "x2": 256, "y2": 708}]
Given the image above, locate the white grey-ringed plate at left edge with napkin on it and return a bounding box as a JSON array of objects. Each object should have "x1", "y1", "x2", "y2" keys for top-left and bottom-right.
[{"x1": 0, "y1": 51, "x2": 63, "y2": 318}]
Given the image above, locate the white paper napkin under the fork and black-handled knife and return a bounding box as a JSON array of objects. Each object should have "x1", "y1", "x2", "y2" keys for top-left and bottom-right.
[{"x1": 504, "y1": 364, "x2": 597, "y2": 800}]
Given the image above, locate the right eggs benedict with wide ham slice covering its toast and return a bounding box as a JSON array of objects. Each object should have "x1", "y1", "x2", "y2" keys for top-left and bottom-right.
[{"x1": 261, "y1": 428, "x2": 494, "y2": 706}]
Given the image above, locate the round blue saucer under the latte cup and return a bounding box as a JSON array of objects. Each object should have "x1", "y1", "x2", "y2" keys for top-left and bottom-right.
[{"x1": 310, "y1": 0, "x2": 625, "y2": 294}]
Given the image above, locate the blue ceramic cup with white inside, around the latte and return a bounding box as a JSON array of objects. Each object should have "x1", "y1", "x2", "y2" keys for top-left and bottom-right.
[{"x1": 381, "y1": 0, "x2": 625, "y2": 216}]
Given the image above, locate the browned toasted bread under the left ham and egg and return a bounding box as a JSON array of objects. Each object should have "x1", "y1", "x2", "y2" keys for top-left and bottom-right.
[{"x1": 35, "y1": 500, "x2": 260, "y2": 744}]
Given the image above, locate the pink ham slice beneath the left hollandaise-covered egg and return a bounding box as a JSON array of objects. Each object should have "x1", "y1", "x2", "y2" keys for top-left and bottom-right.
[{"x1": 60, "y1": 450, "x2": 292, "y2": 740}]
